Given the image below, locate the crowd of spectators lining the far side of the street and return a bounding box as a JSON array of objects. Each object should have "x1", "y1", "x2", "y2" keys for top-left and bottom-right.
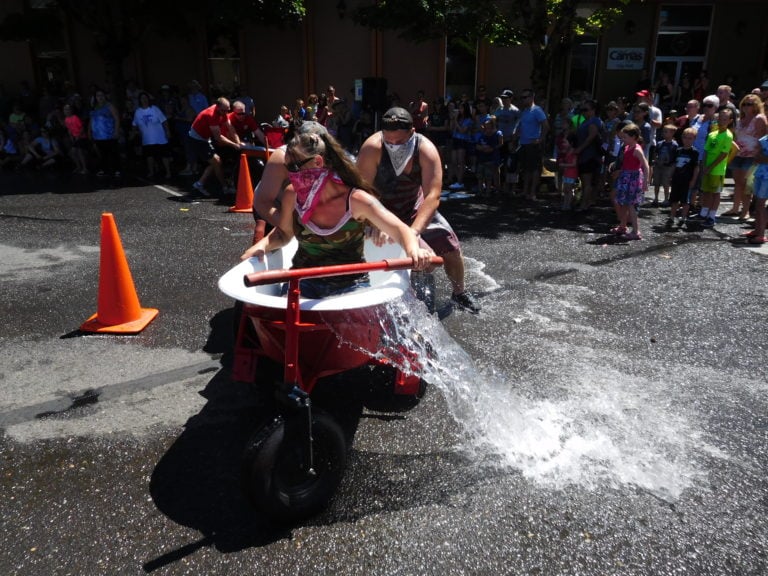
[{"x1": 0, "y1": 71, "x2": 768, "y2": 238}]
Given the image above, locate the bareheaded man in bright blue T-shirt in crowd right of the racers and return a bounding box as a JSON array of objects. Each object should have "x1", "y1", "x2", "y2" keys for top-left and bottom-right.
[{"x1": 516, "y1": 88, "x2": 549, "y2": 200}]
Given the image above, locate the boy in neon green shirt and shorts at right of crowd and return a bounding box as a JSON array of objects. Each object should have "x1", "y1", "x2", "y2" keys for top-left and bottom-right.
[{"x1": 698, "y1": 108, "x2": 733, "y2": 228}]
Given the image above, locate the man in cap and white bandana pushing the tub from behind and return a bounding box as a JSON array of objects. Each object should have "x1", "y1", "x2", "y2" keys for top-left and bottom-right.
[{"x1": 357, "y1": 107, "x2": 480, "y2": 313}]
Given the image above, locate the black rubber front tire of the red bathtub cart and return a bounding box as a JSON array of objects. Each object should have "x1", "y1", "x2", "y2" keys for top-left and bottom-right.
[{"x1": 242, "y1": 410, "x2": 347, "y2": 524}]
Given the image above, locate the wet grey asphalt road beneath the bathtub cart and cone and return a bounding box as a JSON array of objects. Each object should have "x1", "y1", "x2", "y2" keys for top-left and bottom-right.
[{"x1": 0, "y1": 169, "x2": 768, "y2": 576}]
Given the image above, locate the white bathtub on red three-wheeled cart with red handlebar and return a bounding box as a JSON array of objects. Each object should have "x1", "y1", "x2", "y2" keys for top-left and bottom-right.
[{"x1": 219, "y1": 240, "x2": 442, "y2": 522}]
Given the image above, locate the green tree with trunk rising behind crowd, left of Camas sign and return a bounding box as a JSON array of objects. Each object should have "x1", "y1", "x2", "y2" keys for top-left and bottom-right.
[{"x1": 353, "y1": 0, "x2": 630, "y2": 110}]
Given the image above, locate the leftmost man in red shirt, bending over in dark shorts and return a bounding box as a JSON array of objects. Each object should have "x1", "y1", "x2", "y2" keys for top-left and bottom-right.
[{"x1": 188, "y1": 98, "x2": 242, "y2": 196}]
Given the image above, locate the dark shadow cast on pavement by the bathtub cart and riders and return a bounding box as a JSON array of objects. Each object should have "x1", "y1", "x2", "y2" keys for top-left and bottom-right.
[{"x1": 143, "y1": 309, "x2": 504, "y2": 572}]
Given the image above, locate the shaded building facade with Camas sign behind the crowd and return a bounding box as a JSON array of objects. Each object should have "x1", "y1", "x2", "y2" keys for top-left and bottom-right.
[{"x1": 0, "y1": 0, "x2": 768, "y2": 120}]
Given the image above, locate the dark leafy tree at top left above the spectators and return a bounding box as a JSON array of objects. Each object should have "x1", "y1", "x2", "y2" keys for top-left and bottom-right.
[{"x1": 0, "y1": 0, "x2": 305, "y2": 103}]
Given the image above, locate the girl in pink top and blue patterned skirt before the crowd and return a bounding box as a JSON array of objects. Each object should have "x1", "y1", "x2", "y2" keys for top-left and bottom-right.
[{"x1": 611, "y1": 124, "x2": 648, "y2": 240}]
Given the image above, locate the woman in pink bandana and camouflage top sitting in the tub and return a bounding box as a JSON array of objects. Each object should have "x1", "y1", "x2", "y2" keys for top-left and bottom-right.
[{"x1": 242, "y1": 128, "x2": 434, "y2": 298}]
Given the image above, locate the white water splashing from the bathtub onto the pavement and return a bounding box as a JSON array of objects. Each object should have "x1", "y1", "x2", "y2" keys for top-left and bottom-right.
[{"x1": 328, "y1": 280, "x2": 711, "y2": 499}]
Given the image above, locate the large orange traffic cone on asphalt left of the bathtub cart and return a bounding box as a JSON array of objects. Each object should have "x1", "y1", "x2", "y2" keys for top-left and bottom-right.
[{"x1": 80, "y1": 213, "x2": 159, "y2": 334}]
